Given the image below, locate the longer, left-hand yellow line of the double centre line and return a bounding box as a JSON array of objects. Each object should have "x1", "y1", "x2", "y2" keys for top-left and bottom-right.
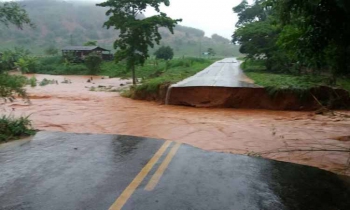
[{"x1": 109, "y1": 141, "x2": 171, "y2": 210}]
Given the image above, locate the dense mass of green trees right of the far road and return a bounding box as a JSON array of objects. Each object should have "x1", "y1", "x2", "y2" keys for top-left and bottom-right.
[{"x1": 233, "y1": 0, "x2": 350, "y2": 85}]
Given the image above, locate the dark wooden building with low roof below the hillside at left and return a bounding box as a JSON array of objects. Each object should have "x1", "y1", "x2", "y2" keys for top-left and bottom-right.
[{"x1": 62, "y1": 46, "x2": 113, "y2": 60}]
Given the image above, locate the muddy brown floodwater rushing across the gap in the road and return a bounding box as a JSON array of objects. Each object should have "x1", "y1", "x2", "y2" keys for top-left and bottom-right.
[{"x1": 2, "y1": 75, "x2": 350, "y2": 175}]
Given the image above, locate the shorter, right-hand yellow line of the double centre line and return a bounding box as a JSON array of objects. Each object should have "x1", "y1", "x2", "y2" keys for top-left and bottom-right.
[{"x1": 145, "y1": 143, "x2": 181, "y2": 191}]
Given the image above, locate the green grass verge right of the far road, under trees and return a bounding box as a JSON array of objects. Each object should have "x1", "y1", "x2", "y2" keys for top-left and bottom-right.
[{"x1": 241, "y1": 60, "x2": 350, "y2": 91}]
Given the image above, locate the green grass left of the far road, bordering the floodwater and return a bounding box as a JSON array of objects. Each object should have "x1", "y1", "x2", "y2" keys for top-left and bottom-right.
[{"x1": 31, "y1": 56, "x2": 216, "y2": 99}]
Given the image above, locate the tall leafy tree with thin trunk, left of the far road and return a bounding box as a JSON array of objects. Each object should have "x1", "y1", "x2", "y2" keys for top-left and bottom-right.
[{"x1": 97, "y1": 0, "x2": 181, "y2": 84}]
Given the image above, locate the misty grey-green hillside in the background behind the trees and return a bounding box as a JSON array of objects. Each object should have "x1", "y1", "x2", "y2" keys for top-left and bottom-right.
[{"x1": 0, "y1": 0, "x2": 238, "y2": 56}]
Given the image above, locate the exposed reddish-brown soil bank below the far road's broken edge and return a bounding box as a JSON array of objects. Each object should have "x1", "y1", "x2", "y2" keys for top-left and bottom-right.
[{"x1": 168, "y1": 87, "x2": 350, "y2": 111}]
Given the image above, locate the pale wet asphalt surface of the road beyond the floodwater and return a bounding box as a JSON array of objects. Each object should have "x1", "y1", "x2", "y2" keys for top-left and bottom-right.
[{"x1": 172, "y1": 58, "x2": 256, "y2": 87}]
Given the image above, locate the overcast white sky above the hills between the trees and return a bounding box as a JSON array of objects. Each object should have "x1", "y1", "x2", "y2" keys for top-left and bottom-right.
[{"x1": 146, "y1": 0, "x2": 245, "y2": 39}]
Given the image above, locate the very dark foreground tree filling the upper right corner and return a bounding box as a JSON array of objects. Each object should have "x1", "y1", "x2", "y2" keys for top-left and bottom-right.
[{"x1": 276, "y1": 0, "x2": 350, "y2": 79}]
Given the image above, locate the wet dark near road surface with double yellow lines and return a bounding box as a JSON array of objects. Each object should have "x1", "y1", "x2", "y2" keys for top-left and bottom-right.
[{"x1": 0, "y1": 132, "x2": 350, "y2": 210}]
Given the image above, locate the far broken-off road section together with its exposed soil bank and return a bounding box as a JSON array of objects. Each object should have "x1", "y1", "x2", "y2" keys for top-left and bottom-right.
[{"x1": 165, "y1": 58, "x2": 350, "y2": 110}]
